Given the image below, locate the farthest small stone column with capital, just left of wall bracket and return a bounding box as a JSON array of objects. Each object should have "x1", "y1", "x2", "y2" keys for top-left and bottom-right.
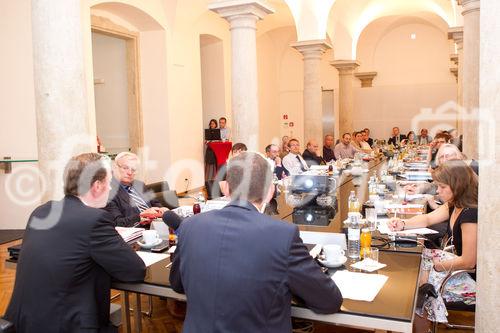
[{"x1": 330, "y1": 60, "x2": 359, "y2": 136}]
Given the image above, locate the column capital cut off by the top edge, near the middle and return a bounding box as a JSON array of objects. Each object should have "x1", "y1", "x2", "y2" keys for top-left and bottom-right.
[{"x1": 208, "y1": 0, "x2": 274, "y2": 22}]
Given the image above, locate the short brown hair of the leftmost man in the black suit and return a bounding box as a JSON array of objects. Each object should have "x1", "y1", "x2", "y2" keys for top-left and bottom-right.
[{"x1": 63, "y1": 153, "x2": 111, "y2": 196}]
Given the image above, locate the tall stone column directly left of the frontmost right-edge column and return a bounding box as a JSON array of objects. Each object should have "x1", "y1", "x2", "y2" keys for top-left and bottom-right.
[{"x1": 458, "y1": 0, "x2": 480, "y2": 159}]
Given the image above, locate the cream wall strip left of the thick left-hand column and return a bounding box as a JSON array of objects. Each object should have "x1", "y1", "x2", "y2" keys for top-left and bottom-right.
[{"x1": 0, "y1": 1, "x2": 40, "y2": 229}]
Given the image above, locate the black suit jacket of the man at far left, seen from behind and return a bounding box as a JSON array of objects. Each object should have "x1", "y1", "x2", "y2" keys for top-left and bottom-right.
[{"x1": 5, "y1": 196, "x2": 146, "y2": 333}]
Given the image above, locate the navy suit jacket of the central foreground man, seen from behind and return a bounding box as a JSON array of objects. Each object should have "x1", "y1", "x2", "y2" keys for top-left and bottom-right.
[{"x1": 170, "y1": 201, "x2": 342, "y2": 333}]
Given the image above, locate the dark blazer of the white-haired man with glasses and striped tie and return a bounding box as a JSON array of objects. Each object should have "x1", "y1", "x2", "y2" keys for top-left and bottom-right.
[{"x1": 104, "y1": 178, "x2": 162, "y2": 227}]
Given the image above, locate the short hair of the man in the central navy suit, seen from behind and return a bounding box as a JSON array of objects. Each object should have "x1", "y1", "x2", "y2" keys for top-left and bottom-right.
[{"x1": 226, "y1": 152, "x2": 273, "y2": 204}]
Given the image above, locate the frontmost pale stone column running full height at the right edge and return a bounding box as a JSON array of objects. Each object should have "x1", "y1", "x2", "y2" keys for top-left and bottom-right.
[{"x1": 475, "y1": 1, "x2": 500, "y2": 333}]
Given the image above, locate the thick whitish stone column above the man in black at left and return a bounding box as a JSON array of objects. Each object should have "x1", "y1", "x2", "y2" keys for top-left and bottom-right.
[{"x1": 31, "y1": 0, "x2": 93, "y2": 201}]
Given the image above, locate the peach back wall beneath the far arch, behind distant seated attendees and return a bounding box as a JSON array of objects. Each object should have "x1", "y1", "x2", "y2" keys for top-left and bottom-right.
[{"x1": 353, "y1": 22, "x2": 457, "y2": 139}]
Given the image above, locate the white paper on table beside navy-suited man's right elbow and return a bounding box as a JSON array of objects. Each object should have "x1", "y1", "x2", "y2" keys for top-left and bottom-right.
[{"x1": 332, "y1": 271, "x2": 389, "y2": 302}]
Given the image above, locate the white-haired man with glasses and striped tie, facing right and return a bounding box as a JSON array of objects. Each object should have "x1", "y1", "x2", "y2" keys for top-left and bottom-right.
[{"x1": 104, "y1": 152, "x2": 167, "y2": 227}]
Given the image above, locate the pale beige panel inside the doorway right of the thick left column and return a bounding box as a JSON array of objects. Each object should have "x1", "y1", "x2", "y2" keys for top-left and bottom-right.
[{"x1": 92, "y1": 33, "x2": 130, "y2": 153}]
